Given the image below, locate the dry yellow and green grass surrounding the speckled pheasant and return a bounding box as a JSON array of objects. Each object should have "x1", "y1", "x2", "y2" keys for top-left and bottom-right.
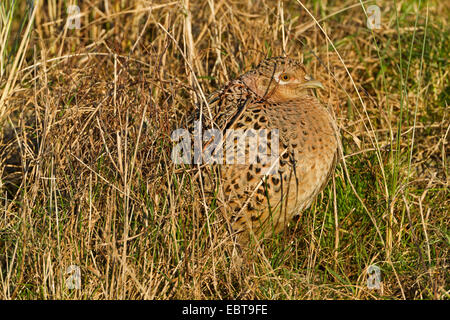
[{"x1": 0, "y1": 0, "x2": 450, "y2": 299}]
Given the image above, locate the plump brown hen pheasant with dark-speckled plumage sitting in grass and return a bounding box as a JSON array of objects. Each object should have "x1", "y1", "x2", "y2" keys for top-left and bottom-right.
[{"x1": 192, "y1": 57, "x2": 338, "y2": 242}]
